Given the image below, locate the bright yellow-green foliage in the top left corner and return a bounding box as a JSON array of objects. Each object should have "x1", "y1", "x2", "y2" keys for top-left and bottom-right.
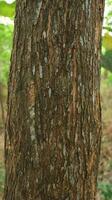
[{"x1": 0, "y1": 1, "x2": 15, "y2": 18}]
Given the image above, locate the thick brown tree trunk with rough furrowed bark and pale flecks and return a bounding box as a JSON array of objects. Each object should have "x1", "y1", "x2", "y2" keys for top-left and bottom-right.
[{"x1": 4, "y1": 0, "x2": 104, "y2": 200}]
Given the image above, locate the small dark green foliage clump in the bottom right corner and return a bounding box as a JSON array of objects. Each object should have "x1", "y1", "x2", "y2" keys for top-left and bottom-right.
[{"x1": 98, "y1": 182, "x2": 112, "y2": 200}]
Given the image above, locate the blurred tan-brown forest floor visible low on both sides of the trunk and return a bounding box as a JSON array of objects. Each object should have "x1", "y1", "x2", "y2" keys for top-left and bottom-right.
[{"x1": 0, "y1": 81, "x2": 112, "y2": 200}]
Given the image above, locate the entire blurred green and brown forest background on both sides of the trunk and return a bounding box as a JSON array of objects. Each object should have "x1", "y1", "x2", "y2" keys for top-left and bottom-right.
[{"x1": 0, "y1": 0, "x2": 112, "y2": 200}]
